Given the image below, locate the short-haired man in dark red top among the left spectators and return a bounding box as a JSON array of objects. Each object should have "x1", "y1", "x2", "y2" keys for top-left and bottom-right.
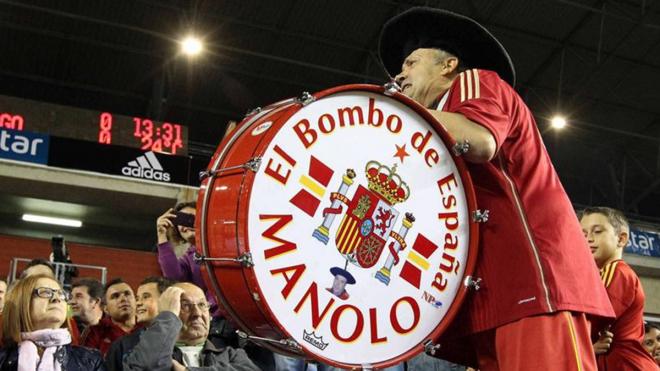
[{"x1": 82, "y1": 278, "x2": 135, "y2": 355}]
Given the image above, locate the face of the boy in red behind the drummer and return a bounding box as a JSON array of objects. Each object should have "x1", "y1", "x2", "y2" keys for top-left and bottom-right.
[{"x1": 580, "y1": 213, "x2": 627, "y2": 268}]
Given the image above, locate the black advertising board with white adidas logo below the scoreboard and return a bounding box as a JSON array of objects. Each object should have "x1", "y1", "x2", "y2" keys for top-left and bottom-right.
[{"x1": 48, "y1": 137, "x2": 191, "y2": 185}]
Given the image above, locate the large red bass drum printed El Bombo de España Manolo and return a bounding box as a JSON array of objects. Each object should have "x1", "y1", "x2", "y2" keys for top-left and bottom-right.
[{"x1": 197, "y1": 85, "x2": 478, "y2": 368}]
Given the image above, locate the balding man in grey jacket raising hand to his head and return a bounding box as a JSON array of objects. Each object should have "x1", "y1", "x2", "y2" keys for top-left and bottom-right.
[{"x1": 123, "y1": 282, "x2": 259, "y2": 371}]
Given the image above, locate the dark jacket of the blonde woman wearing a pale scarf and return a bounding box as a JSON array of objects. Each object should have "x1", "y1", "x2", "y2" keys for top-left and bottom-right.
[{"x1": 0, "y1": 345, "x2": 106, "y2": 371}]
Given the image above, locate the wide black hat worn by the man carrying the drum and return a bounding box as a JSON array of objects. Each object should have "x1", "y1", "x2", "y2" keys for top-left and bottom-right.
[{"x1": 378, "y1": 7, "x2": 516, "y2": 86}]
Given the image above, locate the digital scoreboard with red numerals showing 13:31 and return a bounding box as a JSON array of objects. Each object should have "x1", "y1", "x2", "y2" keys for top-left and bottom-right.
[{"x1": 0, "y1": 95, "x2": 188, "y2": 156}]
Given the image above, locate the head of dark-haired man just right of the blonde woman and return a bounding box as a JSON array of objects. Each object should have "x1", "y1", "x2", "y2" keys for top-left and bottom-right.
[{"x1": 69, "y1": 278, "x2": 103, "y2": 338}]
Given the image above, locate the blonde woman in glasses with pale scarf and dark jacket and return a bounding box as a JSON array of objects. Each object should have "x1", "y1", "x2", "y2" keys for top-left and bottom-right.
[{"x1": 0, "y1": 275, "x2": 105, "y2": 371}]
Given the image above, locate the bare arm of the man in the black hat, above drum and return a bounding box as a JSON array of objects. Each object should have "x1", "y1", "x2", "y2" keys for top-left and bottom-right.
[{"x1": 428, "y1": 110, "x2": 497, "y2": 163}]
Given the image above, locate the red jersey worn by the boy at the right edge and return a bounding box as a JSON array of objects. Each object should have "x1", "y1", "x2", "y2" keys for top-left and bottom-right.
[{"x1": 594, "y1": 260, "x2": 658, "y2": 371}]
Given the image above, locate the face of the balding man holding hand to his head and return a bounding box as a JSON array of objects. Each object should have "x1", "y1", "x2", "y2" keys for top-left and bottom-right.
[{"x1": 179, "y1": 285, "x2": 210, "y2": 345}]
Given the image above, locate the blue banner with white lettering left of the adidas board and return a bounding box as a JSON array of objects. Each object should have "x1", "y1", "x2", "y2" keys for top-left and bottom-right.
[{"x1": 0, "y1": 128, "x2": 49, "y2": 165}]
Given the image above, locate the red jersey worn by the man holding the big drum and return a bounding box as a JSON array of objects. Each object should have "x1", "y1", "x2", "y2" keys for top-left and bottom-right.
[{"x1": 438, "y1": 69, "x2": 613, "y2": 333}]
